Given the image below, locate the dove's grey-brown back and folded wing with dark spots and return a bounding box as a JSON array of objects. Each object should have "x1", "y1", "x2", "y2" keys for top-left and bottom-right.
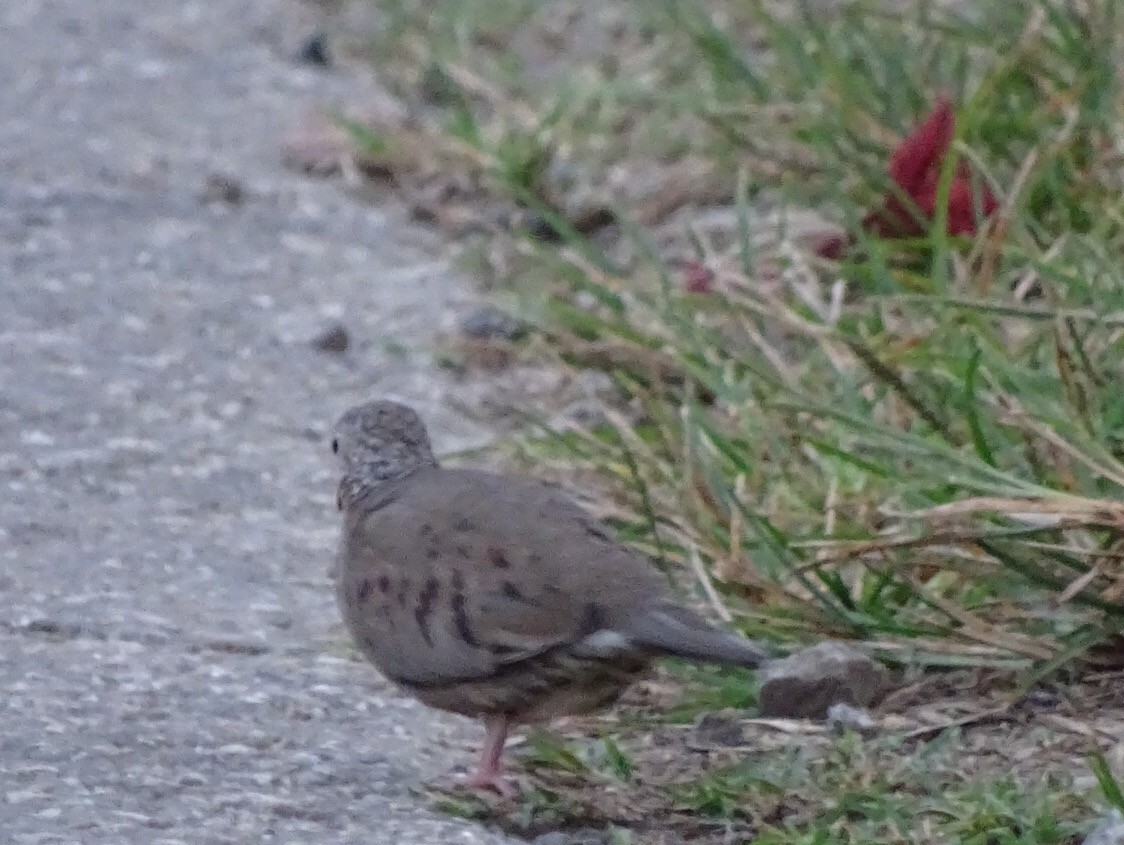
[{"x1": 339, "y1": 469, "x2": 663, "y2": 685}]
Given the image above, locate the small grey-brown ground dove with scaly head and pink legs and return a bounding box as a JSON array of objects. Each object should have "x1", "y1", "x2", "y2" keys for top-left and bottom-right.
[{"x1": 332, "y1": 401, "x2": 764, "y2": 794}]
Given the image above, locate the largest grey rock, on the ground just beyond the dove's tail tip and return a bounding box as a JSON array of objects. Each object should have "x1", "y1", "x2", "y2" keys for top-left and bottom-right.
[{"x1": 761, "y1": 642, "x2": 887, "y2": 719}]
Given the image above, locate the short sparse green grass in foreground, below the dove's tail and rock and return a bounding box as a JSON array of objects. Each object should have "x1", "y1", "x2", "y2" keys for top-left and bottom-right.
[{"x1": 429, "y1": 714, "x2": 1113, "y2": 845}]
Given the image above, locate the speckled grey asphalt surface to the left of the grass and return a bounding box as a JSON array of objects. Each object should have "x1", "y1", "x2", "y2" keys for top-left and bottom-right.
[{"x1": 0, "y1": 0, "x2": 517, "y2": 845}]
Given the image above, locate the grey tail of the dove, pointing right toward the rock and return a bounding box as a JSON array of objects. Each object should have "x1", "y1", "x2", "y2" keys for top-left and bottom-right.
[{"x1": 620, "y1": 605, "x2": 769, "y2": 669}]
